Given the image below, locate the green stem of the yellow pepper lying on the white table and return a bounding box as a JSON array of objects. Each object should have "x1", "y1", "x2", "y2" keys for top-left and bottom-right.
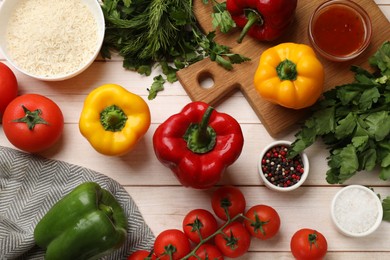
[{"x1": 100, "y1": 105, "x2": 127, "y2": 132}]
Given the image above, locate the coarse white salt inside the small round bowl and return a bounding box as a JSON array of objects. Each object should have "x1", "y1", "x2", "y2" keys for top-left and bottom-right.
[{"x1": 333, "y1": 187, "x2": 380, "y2": 234}]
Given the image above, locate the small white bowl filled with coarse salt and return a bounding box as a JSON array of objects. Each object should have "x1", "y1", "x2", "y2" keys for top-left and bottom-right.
[{"x1": 331, "y1": 185, "x2": 383, "y2": 237}]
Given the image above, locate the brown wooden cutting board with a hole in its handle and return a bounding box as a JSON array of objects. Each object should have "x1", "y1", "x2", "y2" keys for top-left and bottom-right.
[{"x1": 177, "y1": 0, "x2": 390, "y2": 137}]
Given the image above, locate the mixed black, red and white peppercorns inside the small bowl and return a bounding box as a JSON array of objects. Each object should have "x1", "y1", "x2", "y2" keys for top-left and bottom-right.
[{"x1": 261, "y1": 145, "x2": 304, "y2": 187}]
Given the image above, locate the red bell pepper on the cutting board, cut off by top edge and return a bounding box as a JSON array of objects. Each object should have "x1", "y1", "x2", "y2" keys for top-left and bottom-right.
[{"x1": 226, "y1": 0, "x2": 297, "y2": 43}]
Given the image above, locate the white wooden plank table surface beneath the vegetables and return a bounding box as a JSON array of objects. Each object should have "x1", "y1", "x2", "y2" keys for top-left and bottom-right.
[{"x1": 0, "y1": 0, "x2": 390, "y2": 259}]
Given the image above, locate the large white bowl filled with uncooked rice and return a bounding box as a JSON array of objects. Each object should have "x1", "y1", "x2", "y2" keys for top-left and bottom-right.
[{"x1": 0, "y1": 0, "x2": 105, "y2": 81}]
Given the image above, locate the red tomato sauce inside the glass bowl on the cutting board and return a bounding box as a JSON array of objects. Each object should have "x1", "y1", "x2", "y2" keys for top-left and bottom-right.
[{"x1": 313, "y1": 5, "x2": 365, "y2": 56}]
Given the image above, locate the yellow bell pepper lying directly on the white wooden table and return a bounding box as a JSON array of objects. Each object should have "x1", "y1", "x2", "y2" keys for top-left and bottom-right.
[{"x1": 79, "y1": 84, "x2": 150, "y2": 155}]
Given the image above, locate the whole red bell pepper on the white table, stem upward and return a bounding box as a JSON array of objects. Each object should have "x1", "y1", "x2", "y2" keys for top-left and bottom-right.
[{"x1": 153, "y1": 102, "x2": 244, "y2": 189}]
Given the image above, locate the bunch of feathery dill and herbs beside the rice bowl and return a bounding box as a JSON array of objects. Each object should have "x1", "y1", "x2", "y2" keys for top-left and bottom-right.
[{"x1": 101, "y1": 0, "x2": 249, "y2": 99}]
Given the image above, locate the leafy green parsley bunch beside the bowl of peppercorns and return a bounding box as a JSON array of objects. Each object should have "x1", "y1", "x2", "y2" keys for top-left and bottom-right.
[{"x1": 288, "y1": 41, "x2": 390, "y2": 184}]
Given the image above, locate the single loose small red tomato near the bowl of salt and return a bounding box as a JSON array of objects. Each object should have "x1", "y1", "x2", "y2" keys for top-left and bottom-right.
[{"x1": 290, "y1": 228, "x2": 328, "y2": 260}]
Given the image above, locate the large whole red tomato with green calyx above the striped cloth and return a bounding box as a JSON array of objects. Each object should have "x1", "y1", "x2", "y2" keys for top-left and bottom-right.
[{"x1": 3, "y1": 94, "x2": 64, "y2": 153}]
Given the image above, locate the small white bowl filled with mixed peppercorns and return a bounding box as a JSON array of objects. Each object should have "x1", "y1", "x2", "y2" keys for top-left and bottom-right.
[{"x1": 258, "y1": 140, "x2": 309, "y2": 192}]
